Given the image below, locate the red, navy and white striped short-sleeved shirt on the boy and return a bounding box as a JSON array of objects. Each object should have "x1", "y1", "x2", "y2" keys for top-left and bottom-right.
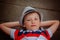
[{"x1": 11, "y1": 29, "x2": 52, "y2": 40}]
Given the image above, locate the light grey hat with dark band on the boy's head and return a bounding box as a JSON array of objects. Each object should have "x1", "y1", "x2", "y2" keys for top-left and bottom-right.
[{"x1": 19, "y1": 6, "x2": 41, "y2": 26}]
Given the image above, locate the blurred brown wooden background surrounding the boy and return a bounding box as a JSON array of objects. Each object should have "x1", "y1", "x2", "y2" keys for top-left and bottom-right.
[{"x1": 0, "y1": 0, "x2": 60, "y2": 40}]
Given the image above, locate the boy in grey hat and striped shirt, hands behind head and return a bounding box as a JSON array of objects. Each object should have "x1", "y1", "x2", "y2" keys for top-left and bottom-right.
[{"x1": 0, "y1": 6, "x2": 59, "y2": 40}]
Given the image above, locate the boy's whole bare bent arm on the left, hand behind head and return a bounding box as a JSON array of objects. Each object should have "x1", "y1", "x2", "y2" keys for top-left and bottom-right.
[{"x1": 0, "y1": 21, "x2": 20, "y2": 35}]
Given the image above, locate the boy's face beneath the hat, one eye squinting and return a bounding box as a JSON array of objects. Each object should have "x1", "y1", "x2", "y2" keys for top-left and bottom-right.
[{"x1": 24, "y1": 13, "x2": 40, "y2": 30}]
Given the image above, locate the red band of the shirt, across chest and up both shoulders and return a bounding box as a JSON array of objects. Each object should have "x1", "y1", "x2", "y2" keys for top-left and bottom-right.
[{"x1": 14, "y1": 30, "x2": 50, "y2": 40}]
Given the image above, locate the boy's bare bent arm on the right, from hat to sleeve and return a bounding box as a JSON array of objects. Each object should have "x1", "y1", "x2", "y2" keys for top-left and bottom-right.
[{"x1": 41, "y1": 20, "x2": 59, "y2": 33}]
